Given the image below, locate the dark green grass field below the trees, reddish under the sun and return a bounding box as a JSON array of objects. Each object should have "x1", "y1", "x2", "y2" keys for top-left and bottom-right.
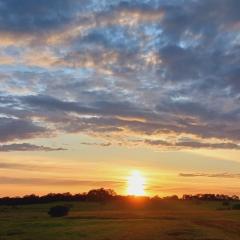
[{"x1": 0, "y1": 201, "x2": 240, "y2": 240}]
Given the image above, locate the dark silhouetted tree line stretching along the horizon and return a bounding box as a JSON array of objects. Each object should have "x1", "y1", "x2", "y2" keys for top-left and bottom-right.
[{"x1": 0, "y1": 188, "x2": 240, "y2": 205}]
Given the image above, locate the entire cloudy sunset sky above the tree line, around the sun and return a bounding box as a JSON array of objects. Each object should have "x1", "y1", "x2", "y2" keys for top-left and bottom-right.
[{"x1": 0, "y1": 0, "x2": 240, "y2": 196}]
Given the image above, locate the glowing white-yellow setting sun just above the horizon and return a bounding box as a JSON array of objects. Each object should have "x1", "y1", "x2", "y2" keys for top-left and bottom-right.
[{"x1": 127, "y1": 171, "x2": 146, "y2": 196}]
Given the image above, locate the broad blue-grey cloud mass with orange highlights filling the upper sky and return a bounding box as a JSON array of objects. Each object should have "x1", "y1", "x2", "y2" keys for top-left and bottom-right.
[{"x1": 0, "y1": 0, "x2": 240, "y2": 150}]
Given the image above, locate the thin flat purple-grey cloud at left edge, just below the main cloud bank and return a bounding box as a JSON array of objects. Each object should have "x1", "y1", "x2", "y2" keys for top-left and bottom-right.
[{"x1": 0, "y1": 143, "x2": 66, "y2": 152}]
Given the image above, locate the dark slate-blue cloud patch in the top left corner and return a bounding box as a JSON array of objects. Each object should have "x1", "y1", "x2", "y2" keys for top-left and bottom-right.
[{"x1": 0, "y1": 0, "x2": 79, "y2": 33}]
